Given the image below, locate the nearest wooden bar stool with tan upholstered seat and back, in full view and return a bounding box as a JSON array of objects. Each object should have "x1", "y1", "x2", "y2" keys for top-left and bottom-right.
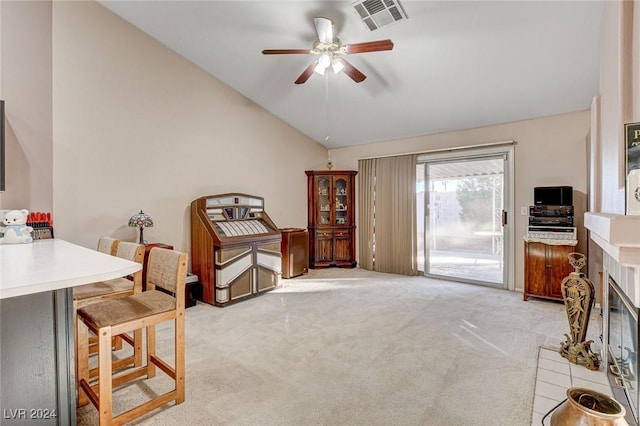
[{"x1": 77, "y1": 247, "x2": 187, "y2": 425}]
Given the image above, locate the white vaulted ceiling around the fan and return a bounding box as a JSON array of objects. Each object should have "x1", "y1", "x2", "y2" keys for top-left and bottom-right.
[{"x1": 100, "y1": 0, "x2": 604, "y2": 148}]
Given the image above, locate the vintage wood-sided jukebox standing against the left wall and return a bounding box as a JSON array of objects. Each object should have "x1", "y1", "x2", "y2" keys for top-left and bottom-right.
[{"x1": 191, "y1": 194, "x2": 282, "y2": 306}]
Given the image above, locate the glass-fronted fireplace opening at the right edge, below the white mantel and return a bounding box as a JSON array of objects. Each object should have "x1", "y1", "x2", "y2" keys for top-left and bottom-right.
[{"x1": 605, "y1": 276, "x2": 640, "y2": 425}]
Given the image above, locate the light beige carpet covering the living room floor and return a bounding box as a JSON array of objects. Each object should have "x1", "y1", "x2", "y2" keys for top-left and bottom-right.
[{"x1": 78, "y1": 269, "x2": 595, "y2": 426}]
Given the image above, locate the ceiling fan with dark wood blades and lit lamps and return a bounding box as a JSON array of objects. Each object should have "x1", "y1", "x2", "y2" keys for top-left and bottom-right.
[{"x1": 262, "y1": 17, "x2": 393, "y2": 84}]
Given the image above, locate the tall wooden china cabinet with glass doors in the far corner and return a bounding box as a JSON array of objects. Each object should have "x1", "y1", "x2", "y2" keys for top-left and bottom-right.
[{"x1": 305, "y1": 170, "x2": 358, "y2": 268}]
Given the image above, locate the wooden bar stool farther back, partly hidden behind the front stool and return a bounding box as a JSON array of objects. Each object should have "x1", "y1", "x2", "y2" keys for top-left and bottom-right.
[{"x1": 73, "y1": 237, "x2": 144, "y2": 386}]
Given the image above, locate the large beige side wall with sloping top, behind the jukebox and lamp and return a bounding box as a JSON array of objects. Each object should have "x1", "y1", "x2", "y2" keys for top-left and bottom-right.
[{"x1": 48, "y1": 2, "x2": 326, "y2": 255}]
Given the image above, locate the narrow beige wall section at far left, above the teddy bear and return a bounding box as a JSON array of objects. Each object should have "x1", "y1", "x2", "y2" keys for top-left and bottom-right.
[{"x1": 0, "y1": 1, "x2": 53, "y2": 212}]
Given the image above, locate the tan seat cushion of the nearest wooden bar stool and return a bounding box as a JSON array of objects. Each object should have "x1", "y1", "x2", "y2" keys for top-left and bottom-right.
[{"x1": 78, "y1": 290, "x2": 176, "y2": 328}]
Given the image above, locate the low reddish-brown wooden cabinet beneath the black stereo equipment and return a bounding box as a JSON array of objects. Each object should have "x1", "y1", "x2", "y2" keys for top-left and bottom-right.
[{"x1": 524, "y1": 242, "x2": 575, "y2": 300}]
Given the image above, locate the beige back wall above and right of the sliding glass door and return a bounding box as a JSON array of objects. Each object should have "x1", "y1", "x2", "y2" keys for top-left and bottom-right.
[{"x1": 331, "y1": 111, "x2": 590, "y2": 291}]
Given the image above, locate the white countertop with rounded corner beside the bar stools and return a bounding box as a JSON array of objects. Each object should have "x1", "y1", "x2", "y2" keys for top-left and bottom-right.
[{"x1": 0, "y1": 238, "x2": 142, "y2": 299}]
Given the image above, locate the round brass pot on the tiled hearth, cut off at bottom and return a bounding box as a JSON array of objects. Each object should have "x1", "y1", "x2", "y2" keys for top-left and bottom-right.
[{"x1": 551, "y1": 388, "x2": 629, "y2": 426}]
